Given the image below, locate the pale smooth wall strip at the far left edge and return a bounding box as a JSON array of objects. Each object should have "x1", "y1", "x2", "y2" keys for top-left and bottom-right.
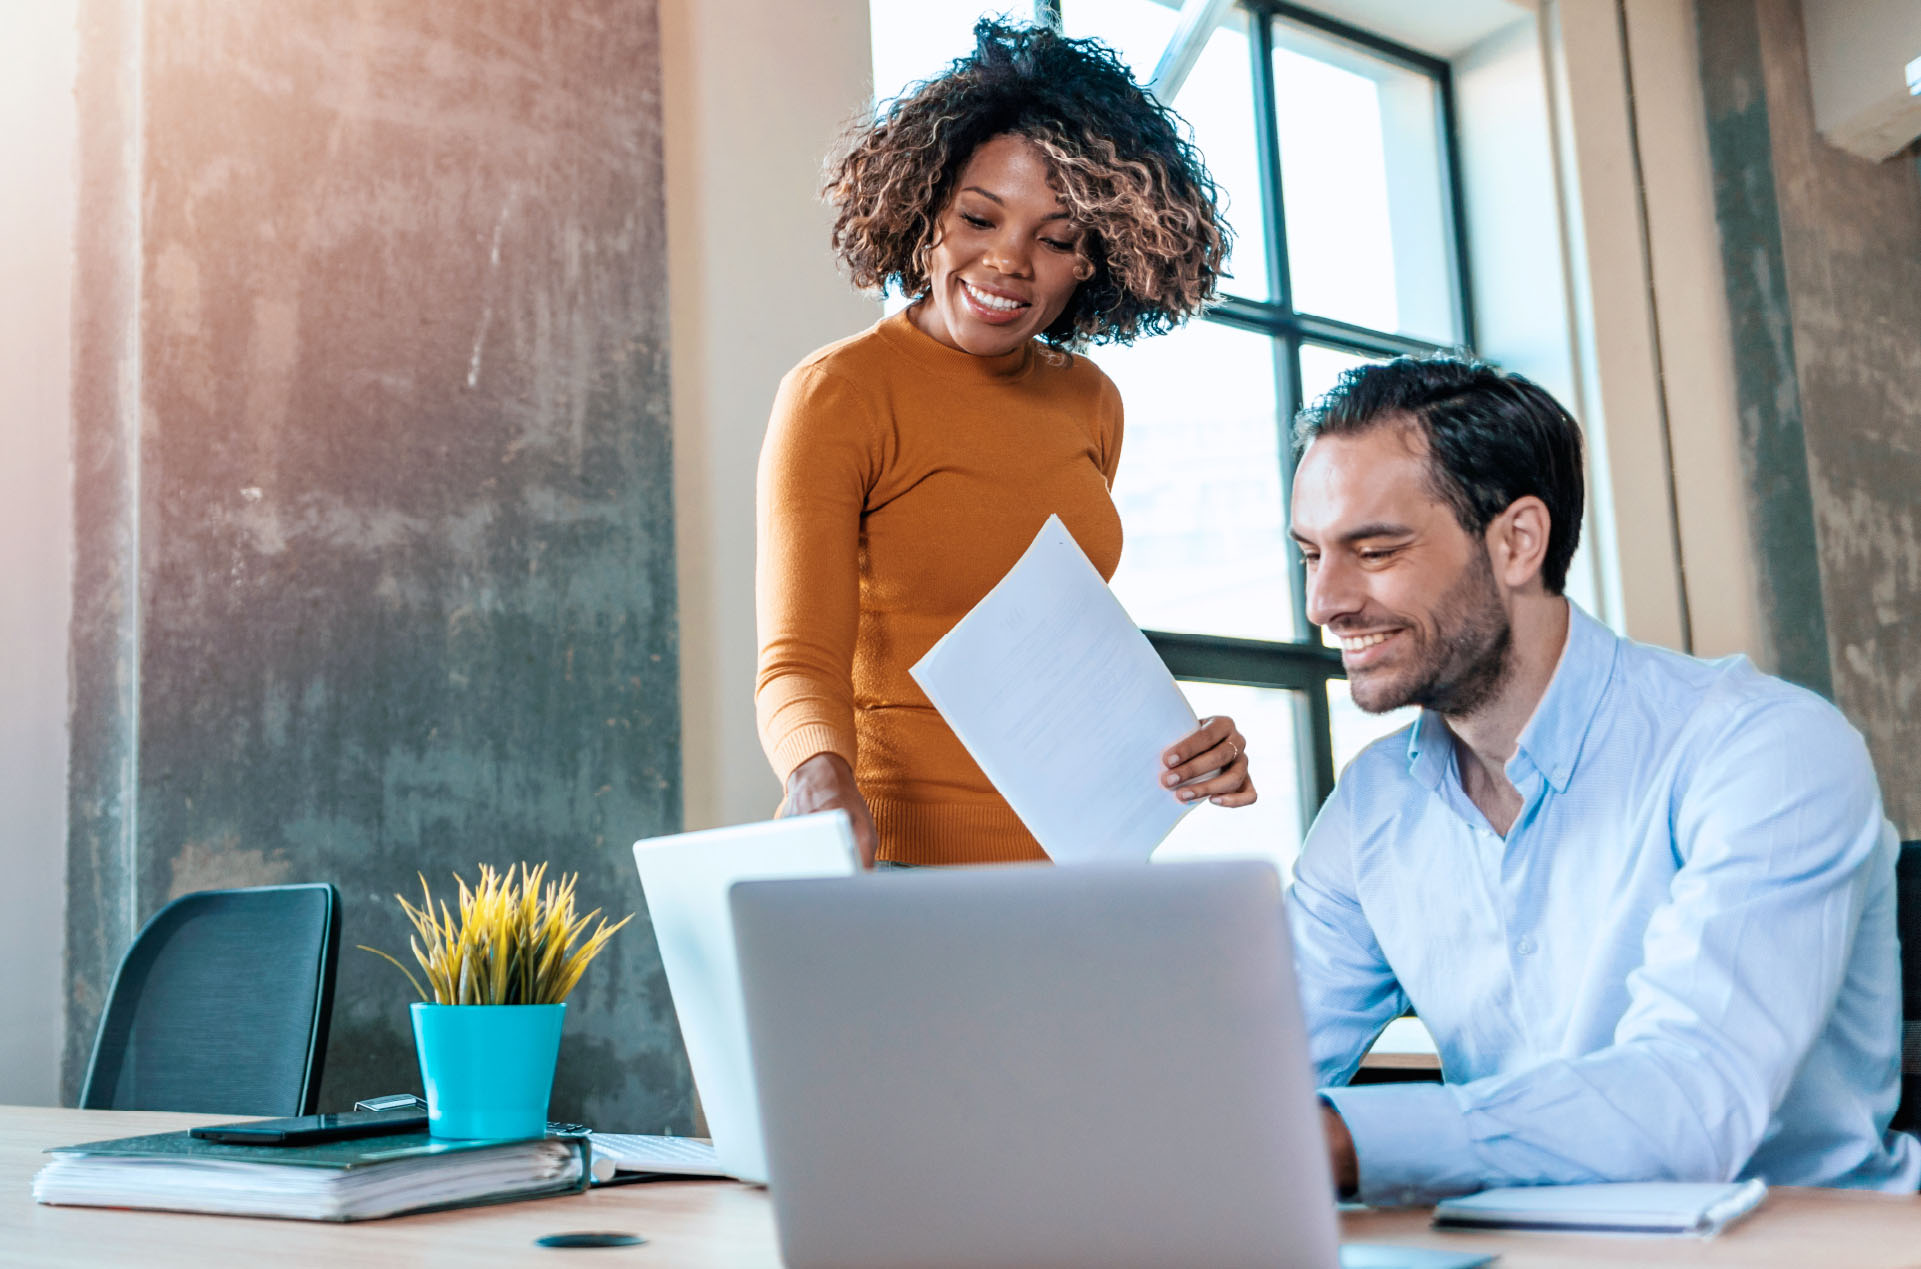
[{"x1": 0, "y1": 0, "x2": 77, "y2": 1106}]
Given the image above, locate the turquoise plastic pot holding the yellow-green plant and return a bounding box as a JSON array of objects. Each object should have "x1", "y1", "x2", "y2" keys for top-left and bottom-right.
[{"x1": 413, "y1": 1002, "x2": 567, "y2": 1138}]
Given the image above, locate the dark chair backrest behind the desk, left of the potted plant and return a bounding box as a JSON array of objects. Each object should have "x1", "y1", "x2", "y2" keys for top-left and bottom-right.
[{"x1": 81, "y1": 885, "x2": 340, "y2": 1115}]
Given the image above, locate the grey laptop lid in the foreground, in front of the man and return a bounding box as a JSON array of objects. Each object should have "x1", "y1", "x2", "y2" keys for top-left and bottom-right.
[{"x1": 734, "y1": 860, "x2": 1337, "y2": 1269}]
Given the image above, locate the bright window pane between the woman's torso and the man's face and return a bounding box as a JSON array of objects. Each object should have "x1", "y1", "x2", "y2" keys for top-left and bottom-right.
[{"x1": 1095, "y1": 321, "x2": 1295, "y2": 639}]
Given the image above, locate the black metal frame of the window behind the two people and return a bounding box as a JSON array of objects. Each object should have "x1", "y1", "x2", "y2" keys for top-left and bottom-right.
[{"x1": 1121, "y1": 0, "x2": 1473, "y2": 833}]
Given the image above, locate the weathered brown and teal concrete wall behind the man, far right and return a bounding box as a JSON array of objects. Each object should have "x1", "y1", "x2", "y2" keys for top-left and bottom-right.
[{"x1": 1696, "y1": 0, "x2": 1921, "y2": 837}]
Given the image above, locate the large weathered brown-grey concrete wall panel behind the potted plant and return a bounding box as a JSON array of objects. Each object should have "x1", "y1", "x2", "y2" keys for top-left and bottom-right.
[{"x1": 65, "y1": 0, "x2": 692, "y2": 1131}]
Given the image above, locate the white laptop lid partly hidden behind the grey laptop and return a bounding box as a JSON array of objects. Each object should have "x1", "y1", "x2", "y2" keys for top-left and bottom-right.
[{"x1": 634, "y1": 810, "x2": 859, "y2": 1185}]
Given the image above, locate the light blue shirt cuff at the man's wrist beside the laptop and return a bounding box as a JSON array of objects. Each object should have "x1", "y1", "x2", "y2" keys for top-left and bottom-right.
[{"x1": 1320, "y1": 1085, "x2": 1485, "y2": 1208}]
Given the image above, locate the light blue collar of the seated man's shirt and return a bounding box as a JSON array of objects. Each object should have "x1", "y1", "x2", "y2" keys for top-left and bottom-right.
[{"x1": 1408, "y1": 599, "x2": 1621, "y2": 793}]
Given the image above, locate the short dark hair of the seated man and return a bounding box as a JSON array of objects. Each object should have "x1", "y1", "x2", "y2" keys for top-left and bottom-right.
[{"x1": 1295, "y1": 357, "x2": 1583, "y2": 595}]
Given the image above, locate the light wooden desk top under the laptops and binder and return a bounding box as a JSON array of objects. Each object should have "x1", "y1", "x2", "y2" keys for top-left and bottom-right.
[{"x1": 0, "y1": 1108, "x2": 1921, "y2": 1269}]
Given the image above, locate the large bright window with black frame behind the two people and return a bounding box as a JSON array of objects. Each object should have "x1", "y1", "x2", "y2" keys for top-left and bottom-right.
[{"x1": 874, "y1": 0, "x2": 1473, "y2": 864}]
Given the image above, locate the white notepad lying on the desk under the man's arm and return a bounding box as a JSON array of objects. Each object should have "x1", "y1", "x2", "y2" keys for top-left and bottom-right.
[{"x1": 1435, "y1": 1181, "x2": 1767, "y2": 1236}]
